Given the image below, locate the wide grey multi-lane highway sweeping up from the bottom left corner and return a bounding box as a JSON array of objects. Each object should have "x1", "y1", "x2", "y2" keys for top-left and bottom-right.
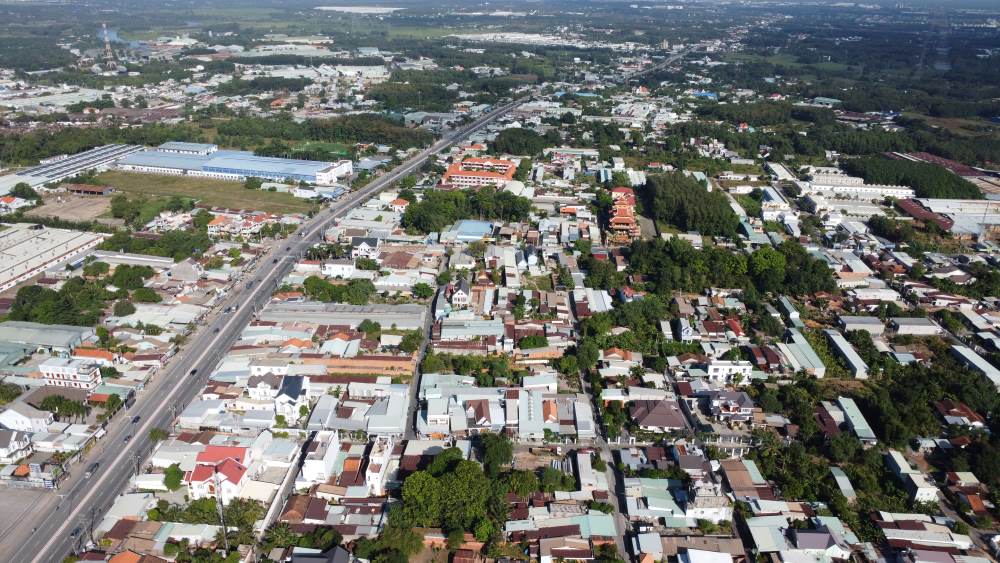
[{"x1": 11, "y1": 97, "x2": 528, "y2": 563}]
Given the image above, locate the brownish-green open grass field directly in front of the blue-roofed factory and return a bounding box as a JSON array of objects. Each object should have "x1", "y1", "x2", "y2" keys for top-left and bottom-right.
[{"x1": 97, "y1": 171, "x2": 312, "y2": 213}]
